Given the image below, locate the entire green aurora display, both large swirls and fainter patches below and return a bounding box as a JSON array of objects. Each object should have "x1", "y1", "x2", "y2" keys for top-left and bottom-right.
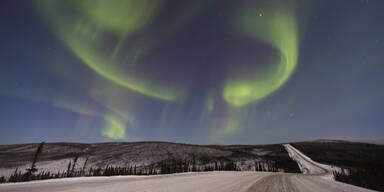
[{"x1": 35, "y1": 0, "x2": 298, "y2": 139}]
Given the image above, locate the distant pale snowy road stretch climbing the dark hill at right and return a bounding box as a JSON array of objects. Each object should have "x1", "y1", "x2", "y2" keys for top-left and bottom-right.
[{"x1": 284, "y1": 144, "x2": 341, "y2": 179}]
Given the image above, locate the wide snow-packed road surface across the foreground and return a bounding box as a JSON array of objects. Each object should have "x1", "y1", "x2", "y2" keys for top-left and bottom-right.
[{"x1": 0, "y1": 171, "x2": 371, "y2": 192}]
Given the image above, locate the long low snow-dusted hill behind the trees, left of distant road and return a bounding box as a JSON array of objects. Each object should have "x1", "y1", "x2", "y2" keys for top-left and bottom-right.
[{"x1": 0, "y1": 142, "x2": 299, "y2": 177}]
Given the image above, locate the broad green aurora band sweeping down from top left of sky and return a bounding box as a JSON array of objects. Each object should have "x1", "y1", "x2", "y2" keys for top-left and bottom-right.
[{"x1": 40, "y1": 0, "x2": 181, "y2": 101}]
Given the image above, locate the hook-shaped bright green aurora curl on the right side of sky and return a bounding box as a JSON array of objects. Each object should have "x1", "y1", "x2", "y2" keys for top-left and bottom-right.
[{"x1": 223, "y1": 1, "x2": 298, "y2": 107}]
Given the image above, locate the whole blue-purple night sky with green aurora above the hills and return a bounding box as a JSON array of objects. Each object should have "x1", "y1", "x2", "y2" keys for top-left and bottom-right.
[{"x1": 0, "y1": 0, "x2": 384, "y2": 144}]
